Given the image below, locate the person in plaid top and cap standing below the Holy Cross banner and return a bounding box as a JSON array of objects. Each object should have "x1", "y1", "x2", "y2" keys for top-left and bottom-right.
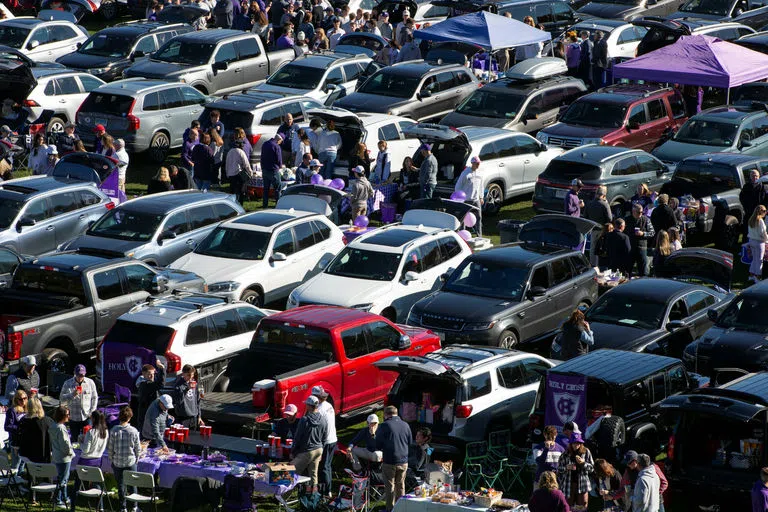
[{"x1": 557, "y1": 432, "x2": 595, "y2": 510}]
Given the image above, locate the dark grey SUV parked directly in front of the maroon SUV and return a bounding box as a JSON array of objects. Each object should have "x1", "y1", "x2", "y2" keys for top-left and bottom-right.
[{"x1": 533, "y1": 145, "x2": 670, "y2": 215}]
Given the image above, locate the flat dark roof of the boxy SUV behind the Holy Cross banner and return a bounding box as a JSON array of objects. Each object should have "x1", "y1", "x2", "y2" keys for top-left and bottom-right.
[{"x1": 549, "y1": 348, "x2": 682, "y2": 385}]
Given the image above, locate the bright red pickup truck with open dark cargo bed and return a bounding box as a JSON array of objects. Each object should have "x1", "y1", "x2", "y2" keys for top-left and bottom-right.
[{"x1": 202, "y1": 306, "x2": 440, "y2": 424}]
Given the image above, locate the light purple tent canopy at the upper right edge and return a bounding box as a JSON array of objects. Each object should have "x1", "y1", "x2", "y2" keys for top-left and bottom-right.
[{"x1": 613, "y1": 36, "x2": 768, "y2": 89}]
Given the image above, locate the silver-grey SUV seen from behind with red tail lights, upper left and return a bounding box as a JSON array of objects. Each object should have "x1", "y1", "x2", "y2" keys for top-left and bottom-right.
[{"x1": 76, "y1": 80, "x2": 208, "y2": 163}]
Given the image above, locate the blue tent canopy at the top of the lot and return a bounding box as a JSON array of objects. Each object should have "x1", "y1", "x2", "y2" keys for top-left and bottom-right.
[{"x1": 413, "y1": 11, "x2": 552, "y2": 51}]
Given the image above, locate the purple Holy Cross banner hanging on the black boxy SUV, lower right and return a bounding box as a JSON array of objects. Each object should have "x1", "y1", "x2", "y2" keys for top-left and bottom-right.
[{"x1": 544, "y1": 372, "x2": 587, "y2": 431}]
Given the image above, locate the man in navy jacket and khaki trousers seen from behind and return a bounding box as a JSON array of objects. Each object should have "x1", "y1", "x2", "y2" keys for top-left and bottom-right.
[{"x1": 376, "y1": 405, "x2": 413, "y2": 512}]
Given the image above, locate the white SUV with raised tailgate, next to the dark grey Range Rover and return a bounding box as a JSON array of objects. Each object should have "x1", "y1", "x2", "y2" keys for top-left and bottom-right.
[{"x1": 288, "y1": 209, "x2": 472, "y2": 323}]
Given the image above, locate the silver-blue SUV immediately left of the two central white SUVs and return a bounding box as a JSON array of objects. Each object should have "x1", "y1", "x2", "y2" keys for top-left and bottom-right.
[{"x1": 59, "y1": 190, "x2": 244, "y2": 266}]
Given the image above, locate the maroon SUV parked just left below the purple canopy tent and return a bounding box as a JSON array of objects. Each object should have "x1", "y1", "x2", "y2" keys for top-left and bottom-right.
[{"x1": 536, "y1": 84, "x2": 688, "y2": 151}]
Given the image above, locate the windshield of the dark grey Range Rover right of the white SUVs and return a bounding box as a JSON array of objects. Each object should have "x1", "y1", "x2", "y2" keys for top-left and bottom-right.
[{"x1": 443, "y1": 260, "x2": 528, "y2": 301}]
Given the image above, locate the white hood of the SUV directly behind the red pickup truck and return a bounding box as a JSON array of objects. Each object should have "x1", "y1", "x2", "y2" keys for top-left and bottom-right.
[{"x1": 299, "y1": 272, "x2": 392, "y2": 307}]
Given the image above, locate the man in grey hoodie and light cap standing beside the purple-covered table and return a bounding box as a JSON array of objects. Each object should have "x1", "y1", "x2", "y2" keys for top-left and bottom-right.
[{"x1": 291, "y1": 395, "x2": 328, "y2": 492}]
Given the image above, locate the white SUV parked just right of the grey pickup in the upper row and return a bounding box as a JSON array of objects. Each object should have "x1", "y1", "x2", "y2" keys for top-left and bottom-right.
[{"x1": 253, "y1": 53, "x2": 371, "y2": 105}]
